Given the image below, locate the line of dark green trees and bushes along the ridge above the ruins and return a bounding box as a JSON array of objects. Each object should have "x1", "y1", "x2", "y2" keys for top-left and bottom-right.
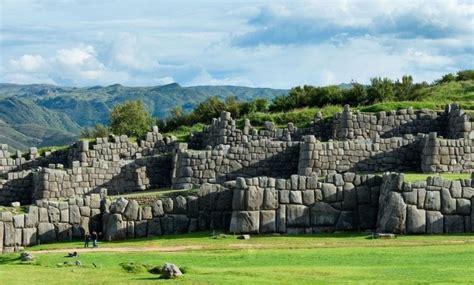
[{"x1": 81, "y1": 70, "x2": 474, "y2": 138}]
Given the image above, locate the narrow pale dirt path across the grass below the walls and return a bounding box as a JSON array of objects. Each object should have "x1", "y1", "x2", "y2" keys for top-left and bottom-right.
[{"x1": 34, "y1": 245, "x2": 206, "y2": 254}]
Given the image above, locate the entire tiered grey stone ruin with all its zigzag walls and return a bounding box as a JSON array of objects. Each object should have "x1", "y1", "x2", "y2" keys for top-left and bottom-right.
[{"x1": 0, "y1": 101, "x2": 474, "y2": 252}]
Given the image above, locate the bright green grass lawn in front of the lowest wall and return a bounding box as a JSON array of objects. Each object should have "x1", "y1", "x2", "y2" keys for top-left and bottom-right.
[{"x1": 0, "y1": 233, "x2": 474, "y2": 284}]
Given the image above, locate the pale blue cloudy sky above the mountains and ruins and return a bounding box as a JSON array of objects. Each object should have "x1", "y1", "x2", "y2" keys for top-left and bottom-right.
[{"x1": 0, "y1": 0, "x2": 474, "y2": 88}]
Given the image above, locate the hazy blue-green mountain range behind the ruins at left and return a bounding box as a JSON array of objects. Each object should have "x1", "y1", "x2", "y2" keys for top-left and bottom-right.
[{"x1": 0, "y1": 83, "x2": 287, "y2": 149}]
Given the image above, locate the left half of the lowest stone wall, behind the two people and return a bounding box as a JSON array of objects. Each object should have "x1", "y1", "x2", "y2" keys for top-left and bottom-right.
[{"x1": 0, "y1": 184, "x2": 232, "y2": 253}]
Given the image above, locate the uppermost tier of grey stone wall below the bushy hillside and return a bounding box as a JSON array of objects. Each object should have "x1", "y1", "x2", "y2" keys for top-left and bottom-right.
[{"x1": 190, "y1": 104, "x2": 474, "y2": 149}]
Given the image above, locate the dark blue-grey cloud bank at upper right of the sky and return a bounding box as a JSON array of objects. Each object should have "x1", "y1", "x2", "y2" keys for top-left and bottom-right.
[{"x1": 233, "y1": 1, "x2": 474, "y2": 47}]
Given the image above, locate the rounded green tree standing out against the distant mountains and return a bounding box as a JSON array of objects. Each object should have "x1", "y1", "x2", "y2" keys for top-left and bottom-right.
[{"x1": 109, "y1": 100, "x2": 153, "y2": 137}]
